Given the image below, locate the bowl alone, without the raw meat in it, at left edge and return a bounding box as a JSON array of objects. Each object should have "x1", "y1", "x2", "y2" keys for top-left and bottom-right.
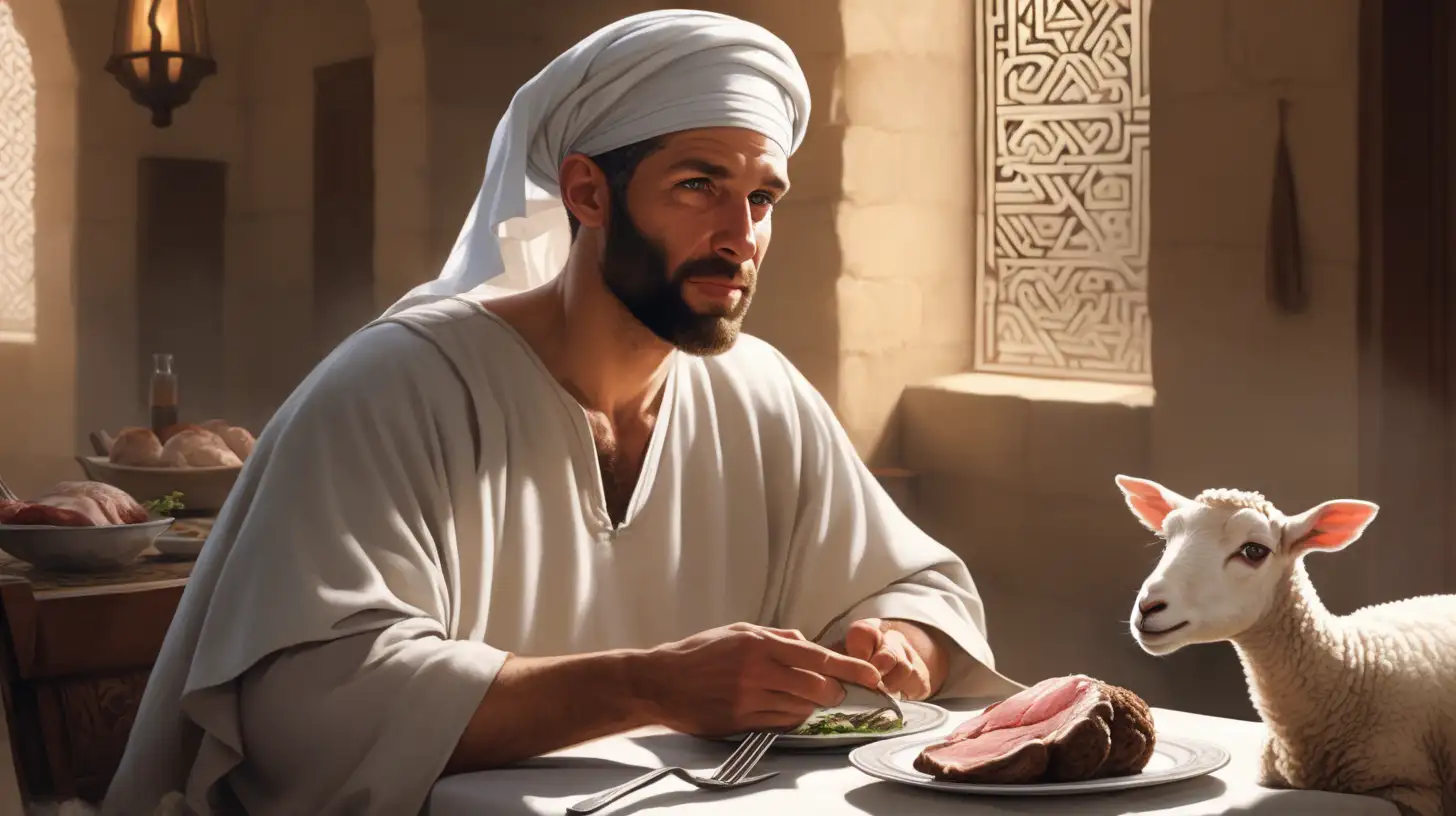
[{"x1": 0, "y1": 516, "x2": 173, "y2": 573}]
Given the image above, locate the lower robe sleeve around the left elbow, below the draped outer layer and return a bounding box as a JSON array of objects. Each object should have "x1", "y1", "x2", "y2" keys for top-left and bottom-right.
[{"x1": 229, "y1": 619, "x2": 498, "y2": 815}]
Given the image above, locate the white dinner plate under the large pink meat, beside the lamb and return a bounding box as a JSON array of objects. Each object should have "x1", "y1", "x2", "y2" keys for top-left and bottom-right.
[{"x1": 849, "y1": 733, "x2": 1229, "y2": 796}]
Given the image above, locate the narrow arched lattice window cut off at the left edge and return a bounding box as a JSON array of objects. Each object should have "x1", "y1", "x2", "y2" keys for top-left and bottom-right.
[{"x1": 0, "y1": 0, "x2": 35, "y2": 342}]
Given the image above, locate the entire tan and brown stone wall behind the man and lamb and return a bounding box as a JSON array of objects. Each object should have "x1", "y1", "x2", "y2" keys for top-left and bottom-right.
[{"x1": 0, "y1": 0, "x2": 1402, "y2": 715}]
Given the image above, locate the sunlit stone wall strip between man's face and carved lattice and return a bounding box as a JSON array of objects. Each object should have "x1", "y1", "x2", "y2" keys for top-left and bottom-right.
[{"x1": 836, "y1": 0, "x2": 976, "y2": 462}]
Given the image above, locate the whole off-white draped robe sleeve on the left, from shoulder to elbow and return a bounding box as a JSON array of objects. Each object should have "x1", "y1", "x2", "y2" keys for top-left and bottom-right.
[{"x1": 116, "y1": 323, "x2": 507, "y2": 815}]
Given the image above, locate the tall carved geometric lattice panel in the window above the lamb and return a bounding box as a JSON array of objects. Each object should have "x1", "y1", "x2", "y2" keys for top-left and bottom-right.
[{"x1": 976, "y1": 0, "x2": 1152, "y2": 383}]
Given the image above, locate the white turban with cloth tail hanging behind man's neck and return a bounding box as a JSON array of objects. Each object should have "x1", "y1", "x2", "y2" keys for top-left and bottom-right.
[{"x1": 389, "y1": 10, "x2": 810, "y2": 313}]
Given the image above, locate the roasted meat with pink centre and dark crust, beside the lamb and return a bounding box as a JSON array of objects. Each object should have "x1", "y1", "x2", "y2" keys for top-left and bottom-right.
[{"x1": 914, "y1": 675, "x2": 1153, "y2": 784}]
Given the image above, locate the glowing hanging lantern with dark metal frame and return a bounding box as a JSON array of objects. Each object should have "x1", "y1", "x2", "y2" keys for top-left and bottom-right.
[{"x1": 106, "y1": 0, "x2": 217, "y2": 127}]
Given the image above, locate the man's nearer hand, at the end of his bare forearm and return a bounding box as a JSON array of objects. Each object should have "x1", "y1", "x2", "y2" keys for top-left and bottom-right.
[{"x1": 638, "y1": 624, "x2": 881, "y2": 734}]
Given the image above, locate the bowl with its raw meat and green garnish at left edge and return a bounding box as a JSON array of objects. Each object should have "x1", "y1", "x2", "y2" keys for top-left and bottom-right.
[{"x1": 0, "y1": 481, "x2": 173, "y2": 573}]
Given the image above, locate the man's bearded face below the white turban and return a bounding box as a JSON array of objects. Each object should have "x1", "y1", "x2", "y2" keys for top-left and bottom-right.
[{"x1": 601, "y1": 128, "x2": 789, "y2": 354}]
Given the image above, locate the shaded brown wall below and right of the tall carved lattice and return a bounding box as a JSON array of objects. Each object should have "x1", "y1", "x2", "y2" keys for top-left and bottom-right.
[{"x1": 903, "y1": 0, "x2": 1368, "y2": 717}]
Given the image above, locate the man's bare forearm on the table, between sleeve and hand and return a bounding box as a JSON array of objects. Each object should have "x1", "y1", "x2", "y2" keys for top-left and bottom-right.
[{"x1": 446, "y1": 650, "x2": 652, "y2": 774}]
